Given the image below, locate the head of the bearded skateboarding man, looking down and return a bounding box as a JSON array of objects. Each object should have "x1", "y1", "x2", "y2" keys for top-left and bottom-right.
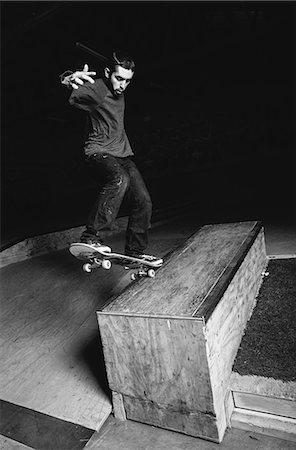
[{"x1": 105, "y1": 52, "x2": 136, "y2": 96}]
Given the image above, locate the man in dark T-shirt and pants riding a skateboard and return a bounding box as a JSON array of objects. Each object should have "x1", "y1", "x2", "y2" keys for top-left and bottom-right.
[{"x1": 60, "y1": 52, "x2": 159, "y2": 260}]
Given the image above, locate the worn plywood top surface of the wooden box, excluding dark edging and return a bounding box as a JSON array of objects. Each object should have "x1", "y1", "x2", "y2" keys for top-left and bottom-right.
[{"x1": 104, "y1": 222, "x2": 256, "y2": 316}]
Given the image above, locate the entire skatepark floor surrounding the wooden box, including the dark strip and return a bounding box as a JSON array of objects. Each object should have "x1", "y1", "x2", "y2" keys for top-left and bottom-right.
[{"x1": 0, "y1": 214, "x2": 296, "y2": 450}]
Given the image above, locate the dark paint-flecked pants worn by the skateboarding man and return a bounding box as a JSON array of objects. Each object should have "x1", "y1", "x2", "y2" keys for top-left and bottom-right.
[{"x1": 84, "y1": 154, "x2": 152, "y2": 253}]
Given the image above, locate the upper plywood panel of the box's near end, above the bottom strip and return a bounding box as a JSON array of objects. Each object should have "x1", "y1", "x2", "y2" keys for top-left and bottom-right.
[{"x1": 98, "y1": 313, "x2": 213, "y2": 411}]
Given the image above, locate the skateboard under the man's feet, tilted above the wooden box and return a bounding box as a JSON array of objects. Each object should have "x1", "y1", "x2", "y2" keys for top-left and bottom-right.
[{"x1": 69, "y1": 242, "x2": 163, "y2": 280}]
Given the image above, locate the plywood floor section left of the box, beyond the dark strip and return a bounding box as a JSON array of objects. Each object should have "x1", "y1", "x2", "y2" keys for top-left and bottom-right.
[{"x1": 0, "y1": 251, "x2": 117, "y2": 429}]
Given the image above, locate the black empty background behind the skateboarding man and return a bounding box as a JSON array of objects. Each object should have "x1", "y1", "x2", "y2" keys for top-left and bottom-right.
[{"x1": 1, "y1": 1, "x2": 295, "y2": 248}]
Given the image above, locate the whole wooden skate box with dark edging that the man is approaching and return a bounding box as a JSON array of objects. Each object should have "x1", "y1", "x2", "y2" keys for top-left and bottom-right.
[{"x1": 97, "y1": 222, "x2": 267, "y2": 442}]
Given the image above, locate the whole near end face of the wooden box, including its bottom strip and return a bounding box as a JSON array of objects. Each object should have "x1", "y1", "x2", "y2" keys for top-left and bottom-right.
[{"x1": 98, "y1": 315, "x2": 219, "y2": 441}]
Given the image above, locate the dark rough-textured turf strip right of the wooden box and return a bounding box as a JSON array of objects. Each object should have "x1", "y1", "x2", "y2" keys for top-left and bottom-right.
[{"x1": 233, "y1": 258, "x2": 296, "y2": 381}]
